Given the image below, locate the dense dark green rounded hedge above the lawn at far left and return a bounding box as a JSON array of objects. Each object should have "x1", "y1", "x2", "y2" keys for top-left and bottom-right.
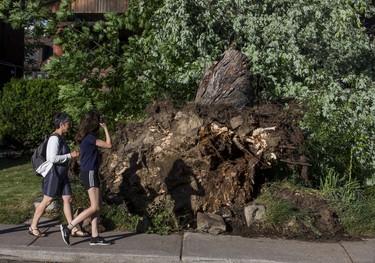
[{"x1": 0, "y1": 79, "x2": 62, "y2": 147}]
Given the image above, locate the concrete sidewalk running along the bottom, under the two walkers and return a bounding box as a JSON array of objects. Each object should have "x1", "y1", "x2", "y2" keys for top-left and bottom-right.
[{"x1": 0, "y1": 220, "x2": 375, "y2": 263}]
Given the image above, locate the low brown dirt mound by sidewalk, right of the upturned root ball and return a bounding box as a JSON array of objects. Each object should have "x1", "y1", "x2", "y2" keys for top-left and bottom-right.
[{"x1": 231, "y1": 183, "x2": 346, "y2": 242}]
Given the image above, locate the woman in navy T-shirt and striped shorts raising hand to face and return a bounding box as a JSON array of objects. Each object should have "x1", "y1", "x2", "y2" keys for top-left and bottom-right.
[{"x1": 60, "y1": 110, "x2": 112, "y2": 245}]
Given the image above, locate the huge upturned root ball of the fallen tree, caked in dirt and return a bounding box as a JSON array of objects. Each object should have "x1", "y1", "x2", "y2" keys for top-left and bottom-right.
[{"x1": 70, "y1": 101, "x2": 346, "y2": 240}]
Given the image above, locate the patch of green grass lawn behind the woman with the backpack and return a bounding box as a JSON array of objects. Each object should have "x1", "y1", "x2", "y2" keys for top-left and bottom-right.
[{"x1": 0, "y1": 156, "x2": 42, "y2": 224}]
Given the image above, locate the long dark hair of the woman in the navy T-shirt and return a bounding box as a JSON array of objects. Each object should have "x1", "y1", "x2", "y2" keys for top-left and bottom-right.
[{"x1": 75, "y1": 109, "x2": 100, "y2": 143}]
